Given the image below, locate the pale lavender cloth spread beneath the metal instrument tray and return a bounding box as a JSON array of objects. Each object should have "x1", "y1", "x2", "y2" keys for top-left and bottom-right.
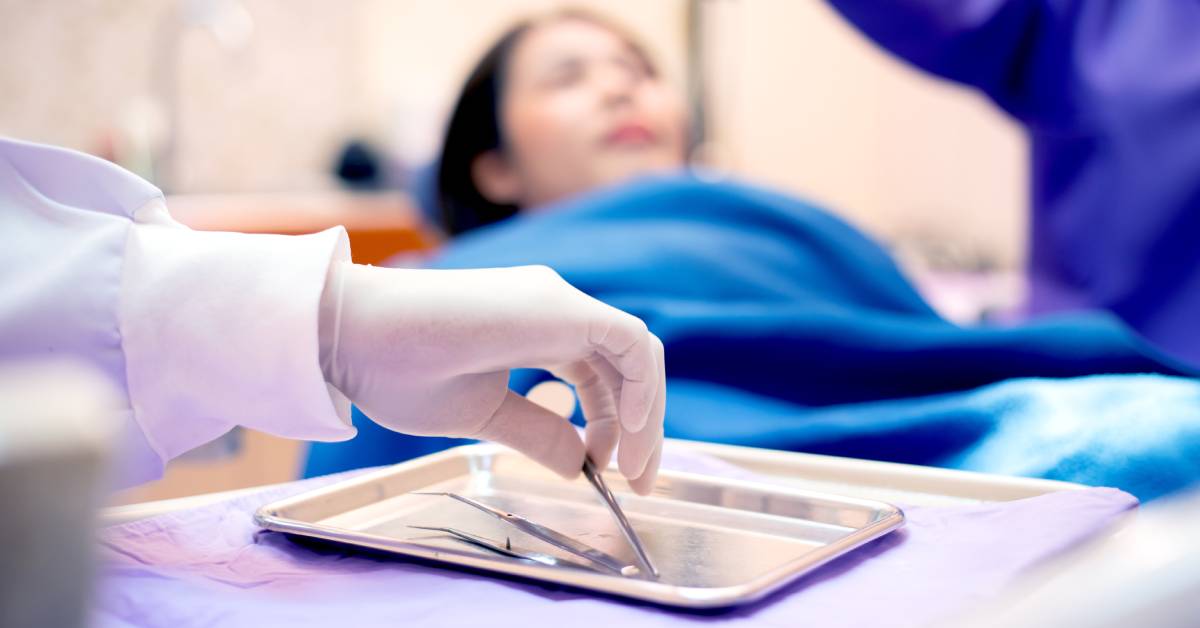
[{"x1": 94, "y1": 450, "x2": 1136, "y2": 628}]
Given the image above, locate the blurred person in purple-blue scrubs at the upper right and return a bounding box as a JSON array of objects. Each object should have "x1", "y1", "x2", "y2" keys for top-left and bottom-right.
[{"x1": 830, "y1": 0, "x2": 1200, "y2": 365}]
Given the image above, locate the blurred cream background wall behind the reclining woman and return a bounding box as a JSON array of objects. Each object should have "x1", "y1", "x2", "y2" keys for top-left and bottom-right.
[{"x1": 0, "y1": 0, "x2": 1026, "y2": 268}]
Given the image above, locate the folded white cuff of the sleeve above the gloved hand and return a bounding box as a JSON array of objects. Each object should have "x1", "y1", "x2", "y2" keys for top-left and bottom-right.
[{"x1": 119, "y1": 199, "x2": 355, "y2": 461}]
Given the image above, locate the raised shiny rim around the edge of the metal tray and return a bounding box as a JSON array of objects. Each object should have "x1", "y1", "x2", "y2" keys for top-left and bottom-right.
[{"x1": 254, "y1": 443, "x2": 906, "y2": 609}]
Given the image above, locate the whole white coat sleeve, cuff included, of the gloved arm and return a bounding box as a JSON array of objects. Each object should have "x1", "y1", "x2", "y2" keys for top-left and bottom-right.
[{"x1": 0, "y1": 137, "x2": 354, "y2": 485}]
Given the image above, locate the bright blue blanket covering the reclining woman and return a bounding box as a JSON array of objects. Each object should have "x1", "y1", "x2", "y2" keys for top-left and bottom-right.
[{"x1": 308, "y1": 177, "x2": 1200, "y2": 498}]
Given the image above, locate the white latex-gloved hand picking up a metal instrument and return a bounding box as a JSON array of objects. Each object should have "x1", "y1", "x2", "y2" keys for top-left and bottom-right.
[{"x1": 320, "y1": 263, "x2": 666, "y2": 495}]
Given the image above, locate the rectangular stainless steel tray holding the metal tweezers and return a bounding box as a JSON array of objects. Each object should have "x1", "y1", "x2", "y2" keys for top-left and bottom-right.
[{"x1": 256, "y1": 444, "x2": 904, "y2": 608}]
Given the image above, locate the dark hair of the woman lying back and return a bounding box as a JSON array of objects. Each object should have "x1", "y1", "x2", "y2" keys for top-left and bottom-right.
[{"x1": 437, "y1": 10, "x2": 652, "y2": 235}]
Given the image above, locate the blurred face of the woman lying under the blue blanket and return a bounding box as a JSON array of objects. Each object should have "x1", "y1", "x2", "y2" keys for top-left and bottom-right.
[{"x1": 487, "y1": 18, "x2": 684, "y2": 208}]
